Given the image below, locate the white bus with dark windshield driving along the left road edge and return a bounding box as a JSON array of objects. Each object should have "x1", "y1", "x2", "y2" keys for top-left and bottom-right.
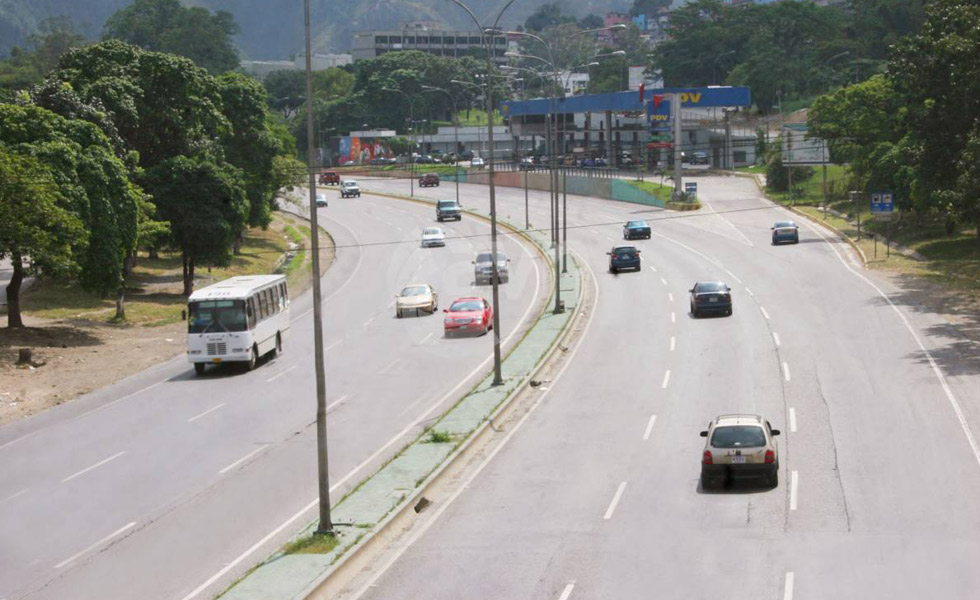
[{"x1": 187, "y1": 275, "x2": 289, "y2": 375}]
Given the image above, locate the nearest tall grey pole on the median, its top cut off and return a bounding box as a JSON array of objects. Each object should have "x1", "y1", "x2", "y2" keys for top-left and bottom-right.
[{"x1": 303, "y1": 0, "x2": 334, "y2": 535}]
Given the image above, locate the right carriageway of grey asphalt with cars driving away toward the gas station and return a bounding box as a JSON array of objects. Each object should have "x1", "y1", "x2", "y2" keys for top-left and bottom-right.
[{"x1": 344, "y1": 177, "x2": 980, "y2": 600}]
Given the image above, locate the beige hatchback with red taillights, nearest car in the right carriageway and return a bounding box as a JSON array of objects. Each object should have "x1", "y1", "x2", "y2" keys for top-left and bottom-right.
[{"x1": 701, "y1": 414, "x2": 779, "y2": 490}]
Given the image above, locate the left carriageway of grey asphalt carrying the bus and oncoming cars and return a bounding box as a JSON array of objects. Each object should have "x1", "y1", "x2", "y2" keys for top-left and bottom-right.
[{"x1": 0, "y1": 191, "x2": 550, "y2": 600}]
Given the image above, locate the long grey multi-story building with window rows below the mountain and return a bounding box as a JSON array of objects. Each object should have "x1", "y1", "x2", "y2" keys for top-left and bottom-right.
[{"x1": 351, "y1": 21, "x2": 507, "y2": 64}]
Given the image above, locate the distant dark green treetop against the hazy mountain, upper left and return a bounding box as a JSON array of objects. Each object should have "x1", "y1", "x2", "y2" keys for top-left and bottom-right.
[{"x1": 103, "y1": 0, "x2": 240, "y2": 74}]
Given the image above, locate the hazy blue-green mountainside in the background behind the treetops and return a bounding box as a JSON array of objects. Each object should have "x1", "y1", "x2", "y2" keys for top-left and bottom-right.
[{"x1": 0, "y1": 0, "x2": 632, "y2": 60}]
